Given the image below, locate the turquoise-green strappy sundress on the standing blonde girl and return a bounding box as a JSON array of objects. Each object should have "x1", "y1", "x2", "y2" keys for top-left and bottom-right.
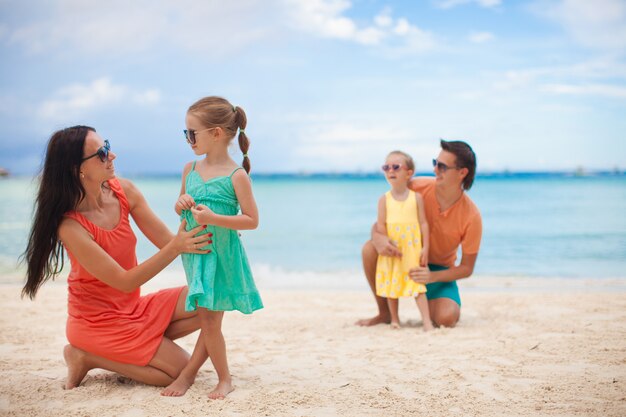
[{"x1": 181, "y1": 162, "x2": 263, "y2": 314}]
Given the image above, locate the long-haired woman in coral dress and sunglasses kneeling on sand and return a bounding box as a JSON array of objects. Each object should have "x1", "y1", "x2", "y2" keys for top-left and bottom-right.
[{"x1": 22, "y1": 126, "x2": 210, "y2": 389}]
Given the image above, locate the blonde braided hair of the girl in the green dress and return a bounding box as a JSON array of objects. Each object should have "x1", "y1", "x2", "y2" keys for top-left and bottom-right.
[{"x1": 187, "y1": 96, "x2": 250, "y2": 173}]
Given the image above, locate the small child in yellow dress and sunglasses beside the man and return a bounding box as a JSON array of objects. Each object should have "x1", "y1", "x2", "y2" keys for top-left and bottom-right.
[{"x1": 376, "y1": 151, "x2": 433, "y2": 331}]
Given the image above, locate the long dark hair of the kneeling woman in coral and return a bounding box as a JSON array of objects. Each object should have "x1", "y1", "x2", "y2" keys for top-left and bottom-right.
[{"x1": 21, "y1": 126, "x2": 96, "y2": 299}]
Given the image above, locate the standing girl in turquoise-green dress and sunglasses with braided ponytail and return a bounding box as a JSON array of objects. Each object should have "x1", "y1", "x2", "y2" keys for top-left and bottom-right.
[{"x1": 162, "y1": 97, "x2": 263, "y2": 399}]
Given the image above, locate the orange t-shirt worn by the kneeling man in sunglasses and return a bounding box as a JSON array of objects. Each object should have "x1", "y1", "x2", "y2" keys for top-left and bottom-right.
[{"x1": 410, "y1": 177, "x2": 483, "y2": 267}]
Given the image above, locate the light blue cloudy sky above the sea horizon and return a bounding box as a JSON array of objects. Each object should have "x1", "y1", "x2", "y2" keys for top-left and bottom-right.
[{"x1": 0, "y1": 0, "x2": 626, "y2": 175}]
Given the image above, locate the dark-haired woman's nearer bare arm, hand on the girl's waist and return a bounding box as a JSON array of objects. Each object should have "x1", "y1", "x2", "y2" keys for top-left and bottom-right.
[{"x1": 59, "y1": 218, "x2": 209, "y2": 292}]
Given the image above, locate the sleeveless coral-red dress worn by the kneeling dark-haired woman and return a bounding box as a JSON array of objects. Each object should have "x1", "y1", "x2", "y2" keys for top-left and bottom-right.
[{"x1": 65, "y1": 179, "x2": 184, "y2": 366}]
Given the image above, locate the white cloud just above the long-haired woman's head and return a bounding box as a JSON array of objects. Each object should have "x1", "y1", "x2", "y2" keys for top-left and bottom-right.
[{"x1": 39, "y1": 77, "x2": 160, "y2": 121}]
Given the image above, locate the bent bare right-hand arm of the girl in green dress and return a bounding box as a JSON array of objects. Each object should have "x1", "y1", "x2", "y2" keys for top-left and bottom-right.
[{"x1": 191, "y1": 170, "x2": 259, "y2": 230}]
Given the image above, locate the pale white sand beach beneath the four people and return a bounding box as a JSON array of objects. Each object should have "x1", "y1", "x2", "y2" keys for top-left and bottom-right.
[{"x1": 0, "y1": 277, "x2": 626, "y2": 417}]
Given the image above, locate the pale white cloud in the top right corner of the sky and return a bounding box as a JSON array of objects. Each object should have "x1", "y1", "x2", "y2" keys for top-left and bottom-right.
[{"x1": 532, "y1": 0, "x2": 626, "y2": 52}]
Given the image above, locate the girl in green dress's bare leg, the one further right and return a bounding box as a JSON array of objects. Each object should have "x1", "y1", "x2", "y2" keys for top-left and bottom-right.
[{"x1": 198, "y1": 308, "x2": 235, "y2": 400}]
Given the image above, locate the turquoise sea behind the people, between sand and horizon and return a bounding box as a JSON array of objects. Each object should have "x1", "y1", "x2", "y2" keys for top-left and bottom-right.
[{"x1": 0, "y1": 173, "x2": 626, "y2": 282}]
